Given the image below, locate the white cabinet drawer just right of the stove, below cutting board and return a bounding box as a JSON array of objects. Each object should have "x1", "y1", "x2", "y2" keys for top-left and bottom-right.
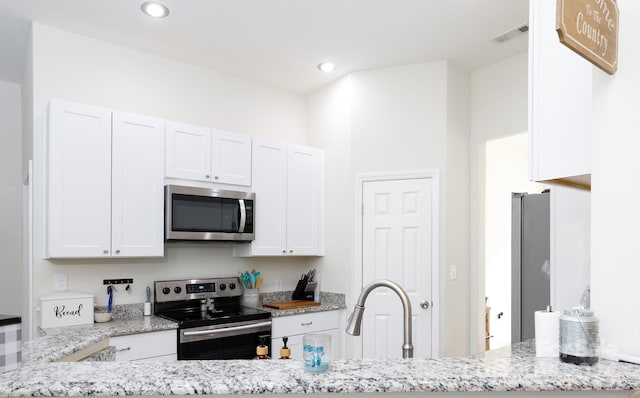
[{"x1": 271, "y1": 311, "x2": 340, "y2": 338}]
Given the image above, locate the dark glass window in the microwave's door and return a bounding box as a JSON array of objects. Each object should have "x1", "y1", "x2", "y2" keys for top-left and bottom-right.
[{"x1": 171, "y1": 194, "x2": 240, "y2": 232}]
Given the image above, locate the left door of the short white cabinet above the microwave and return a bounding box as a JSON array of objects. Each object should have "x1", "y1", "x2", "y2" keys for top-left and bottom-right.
[{"x1": 166, "y1": 122, "x2": 211, "y2": 181}]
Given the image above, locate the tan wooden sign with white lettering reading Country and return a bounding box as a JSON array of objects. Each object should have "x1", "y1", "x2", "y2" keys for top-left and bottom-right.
[{"x1": 556, "y1": 0, "x2": 618, "y2": 75}]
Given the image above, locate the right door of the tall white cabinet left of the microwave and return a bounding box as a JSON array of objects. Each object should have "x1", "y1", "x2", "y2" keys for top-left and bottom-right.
[{"x1": 111, "y1": 112, "x2": 164, "y2": 257}]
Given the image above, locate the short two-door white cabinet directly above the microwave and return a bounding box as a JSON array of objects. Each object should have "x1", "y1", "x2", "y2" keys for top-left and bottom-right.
[{"x1": 166, "y1": 122, "x2": 251, "y2": 186}]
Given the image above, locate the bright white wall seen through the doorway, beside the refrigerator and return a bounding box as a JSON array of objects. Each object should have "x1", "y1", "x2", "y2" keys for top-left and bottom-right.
[{"x1": 484, "y1": 133, "x2": 548, "y2": 349}]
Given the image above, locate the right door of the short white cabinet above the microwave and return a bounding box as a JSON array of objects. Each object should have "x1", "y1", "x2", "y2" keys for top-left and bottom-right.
[{"x1": 211, "y1": 130, "x2": 251, "y2": 186}]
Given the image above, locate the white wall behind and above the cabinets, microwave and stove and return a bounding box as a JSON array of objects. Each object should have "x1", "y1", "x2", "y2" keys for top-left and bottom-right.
[{"x1": 27, "y1": 23, "x2": 318, "y2": 332}]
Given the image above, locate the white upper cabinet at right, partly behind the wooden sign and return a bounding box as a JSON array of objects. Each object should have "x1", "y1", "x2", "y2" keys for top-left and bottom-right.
[{"x1": 529, "y1": 0, "x2": 593, "y2": 185}]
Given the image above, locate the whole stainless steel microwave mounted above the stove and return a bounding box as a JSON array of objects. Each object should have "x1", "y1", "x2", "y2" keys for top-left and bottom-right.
[{"x1": 165, "y1": 185, "x2": 256, "y2": 242}]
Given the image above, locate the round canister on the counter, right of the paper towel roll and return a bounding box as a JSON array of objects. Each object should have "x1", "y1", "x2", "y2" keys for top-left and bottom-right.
[{"x1": 560, "y1": 308, "x2": 600, "y2": 365}]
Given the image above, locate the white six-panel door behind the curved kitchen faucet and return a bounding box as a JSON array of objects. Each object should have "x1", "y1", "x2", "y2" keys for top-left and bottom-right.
[{"x1": 362, "y1": 178, "x2": 433, "y2": 358}]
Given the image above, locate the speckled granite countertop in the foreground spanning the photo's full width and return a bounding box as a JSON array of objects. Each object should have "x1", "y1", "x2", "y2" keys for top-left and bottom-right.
[{"x1": 0, "y1": 343, "x2": 640, "y2": 396}]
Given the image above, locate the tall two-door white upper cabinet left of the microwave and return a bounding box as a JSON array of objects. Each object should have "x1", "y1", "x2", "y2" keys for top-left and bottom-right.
[{"x1": 46, "y1": 100, "x2": 164, "y2": 258}]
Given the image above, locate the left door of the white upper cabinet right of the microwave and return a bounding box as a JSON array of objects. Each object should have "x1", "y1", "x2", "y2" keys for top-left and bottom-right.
[{"x1": 245, "y1": 140, "x2": 287, "y2": 256}]
